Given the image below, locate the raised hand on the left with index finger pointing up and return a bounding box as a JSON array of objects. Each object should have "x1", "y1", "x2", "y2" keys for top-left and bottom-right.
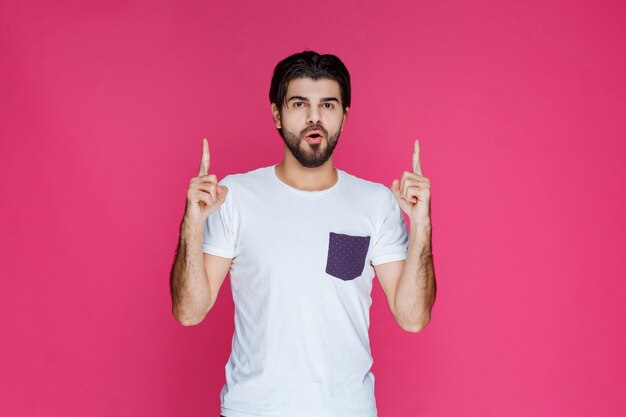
[{"x1": 185, "y1": 139, "x2": 228, "y2": 224}]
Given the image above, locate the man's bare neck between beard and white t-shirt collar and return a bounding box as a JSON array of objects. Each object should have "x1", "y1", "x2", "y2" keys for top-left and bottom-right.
[{"x1": 275, "y1": 147, "x2": 339, "y2": 191}]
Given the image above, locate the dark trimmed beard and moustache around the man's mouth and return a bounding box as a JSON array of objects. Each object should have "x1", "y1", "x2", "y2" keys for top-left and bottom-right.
[{"x1": 278, "y1": 125, "x2": 341, "y2": 168}]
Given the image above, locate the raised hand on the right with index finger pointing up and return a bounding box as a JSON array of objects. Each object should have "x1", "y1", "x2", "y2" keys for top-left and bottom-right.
[{"x1": 391, "y1": 140, "x2": 430, "y2": 225}]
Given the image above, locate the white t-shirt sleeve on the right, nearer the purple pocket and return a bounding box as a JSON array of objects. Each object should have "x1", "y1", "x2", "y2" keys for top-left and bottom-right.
[{"x1": 370, "y1": 186, "x2": 409, "y2": 265}]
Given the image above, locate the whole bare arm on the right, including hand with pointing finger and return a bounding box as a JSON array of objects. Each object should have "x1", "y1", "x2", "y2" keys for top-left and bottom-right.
[{"x1": 374, "y1": 141, "x2": 437, "y2": 333}]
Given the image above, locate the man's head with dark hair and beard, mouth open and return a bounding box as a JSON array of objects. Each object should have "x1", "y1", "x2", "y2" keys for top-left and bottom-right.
[{"x1": 269, "y1": 51, "x2": 351, "y2": 168}]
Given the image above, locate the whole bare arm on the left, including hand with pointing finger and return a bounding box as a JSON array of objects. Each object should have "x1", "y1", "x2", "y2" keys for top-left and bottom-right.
[{"x1": 170, "y1": 139, "x2": 231, "y2": 326}]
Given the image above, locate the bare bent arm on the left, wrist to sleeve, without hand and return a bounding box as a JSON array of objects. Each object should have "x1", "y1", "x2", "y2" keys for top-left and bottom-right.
[{"x1": 170, "y1": 220, "x2": 232, "y2": 326}]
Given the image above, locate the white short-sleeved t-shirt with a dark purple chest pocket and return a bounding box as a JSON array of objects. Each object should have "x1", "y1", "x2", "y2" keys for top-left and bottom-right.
[{"x1": 203, "y1": 165, "x2": 408, "y2": 417}]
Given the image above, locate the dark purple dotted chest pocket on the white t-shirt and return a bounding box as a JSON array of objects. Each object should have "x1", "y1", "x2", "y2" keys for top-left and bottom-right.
[{"x1": 326, "y1": 232, "x2": 370, "y2": 281}]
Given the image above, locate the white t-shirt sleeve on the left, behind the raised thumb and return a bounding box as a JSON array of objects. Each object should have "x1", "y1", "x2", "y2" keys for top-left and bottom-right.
[{"x1": 202, "y1": 176, "x2": 236, "y2": 259}]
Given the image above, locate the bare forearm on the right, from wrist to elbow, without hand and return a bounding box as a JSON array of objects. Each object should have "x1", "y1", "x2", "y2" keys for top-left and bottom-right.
[{"x1": 394, "y1": 222, "x2": 437, "y2": 330}]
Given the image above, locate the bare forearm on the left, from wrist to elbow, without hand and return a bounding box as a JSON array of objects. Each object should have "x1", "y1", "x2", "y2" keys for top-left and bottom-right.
[{"x1": 170, "y1": 219, "x2": 211, "y2": 325}]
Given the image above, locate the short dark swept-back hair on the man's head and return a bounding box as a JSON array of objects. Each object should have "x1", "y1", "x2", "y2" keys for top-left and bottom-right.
[{"x1": 270, "y1": 50, "x2": 351, "y2": 113}]
